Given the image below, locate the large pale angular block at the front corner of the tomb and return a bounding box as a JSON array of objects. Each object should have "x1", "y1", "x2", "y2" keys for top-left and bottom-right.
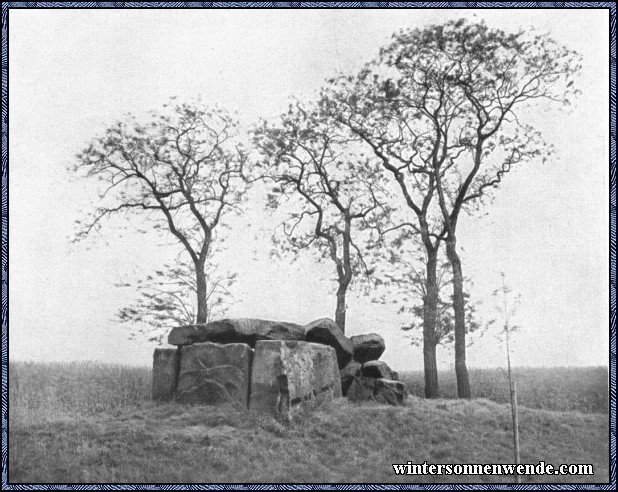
[{"x1": 249, "y1": 340, "x2": 341, "y2": 420}]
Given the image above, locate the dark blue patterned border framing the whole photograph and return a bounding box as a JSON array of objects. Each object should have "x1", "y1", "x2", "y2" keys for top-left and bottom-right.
[{"x1": 2, "y1": 2, "x2": 616, "y2": 490}]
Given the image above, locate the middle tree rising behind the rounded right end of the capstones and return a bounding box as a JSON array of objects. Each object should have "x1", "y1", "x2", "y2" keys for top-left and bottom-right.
[{"x1": 254, "y1": 103, "x2": 385, "y2": 332}]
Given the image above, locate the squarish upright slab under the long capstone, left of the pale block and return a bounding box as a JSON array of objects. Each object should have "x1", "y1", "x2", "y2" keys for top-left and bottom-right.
[{"x1": 176, "y1": 342, "x2": 253, "y2": 408}]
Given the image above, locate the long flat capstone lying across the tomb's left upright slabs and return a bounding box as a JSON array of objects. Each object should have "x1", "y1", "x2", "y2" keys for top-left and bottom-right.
[{"x1": 167, "y1": 318, "x2": 305, "y2": 347}]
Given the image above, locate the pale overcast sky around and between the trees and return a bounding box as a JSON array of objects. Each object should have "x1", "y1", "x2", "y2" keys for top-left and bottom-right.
[{"x1": 9, "y1": 9, "x2": 609, "y2": 370}]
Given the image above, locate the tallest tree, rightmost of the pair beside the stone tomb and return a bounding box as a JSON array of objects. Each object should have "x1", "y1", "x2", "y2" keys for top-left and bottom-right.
[{"x1": 382, "y1": 20, "x2": 579, "y2": 398}]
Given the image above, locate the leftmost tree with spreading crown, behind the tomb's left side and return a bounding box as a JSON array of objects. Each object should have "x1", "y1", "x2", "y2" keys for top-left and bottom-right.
[{"x1": 75, "y1": 99, "x2": 246, "y2": 323}]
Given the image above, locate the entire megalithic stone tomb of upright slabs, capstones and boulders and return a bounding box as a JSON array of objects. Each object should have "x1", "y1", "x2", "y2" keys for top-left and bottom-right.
[{"x1": 152, "y1": 318, "x2": 407, "y2": 420}]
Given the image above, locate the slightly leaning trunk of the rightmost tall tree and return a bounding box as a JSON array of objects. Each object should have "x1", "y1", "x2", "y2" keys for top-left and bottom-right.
[{"x1": 446, "y1": 236, "x2": 470, "y2": 398}]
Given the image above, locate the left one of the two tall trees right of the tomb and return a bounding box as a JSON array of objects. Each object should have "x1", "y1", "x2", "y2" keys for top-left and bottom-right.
[{"x1": 320, "y1": 70, "x2": 444, "y2": 398}]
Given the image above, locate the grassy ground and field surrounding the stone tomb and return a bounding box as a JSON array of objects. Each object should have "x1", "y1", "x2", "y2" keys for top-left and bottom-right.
[{"x1": 8, "y1": 363, "x2": 609, "y2": 483}]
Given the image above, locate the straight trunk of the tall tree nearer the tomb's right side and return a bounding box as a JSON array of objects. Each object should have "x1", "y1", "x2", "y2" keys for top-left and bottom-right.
[{"x1": 423, "y1": 248, "x2": 439, "y2": 398}]
